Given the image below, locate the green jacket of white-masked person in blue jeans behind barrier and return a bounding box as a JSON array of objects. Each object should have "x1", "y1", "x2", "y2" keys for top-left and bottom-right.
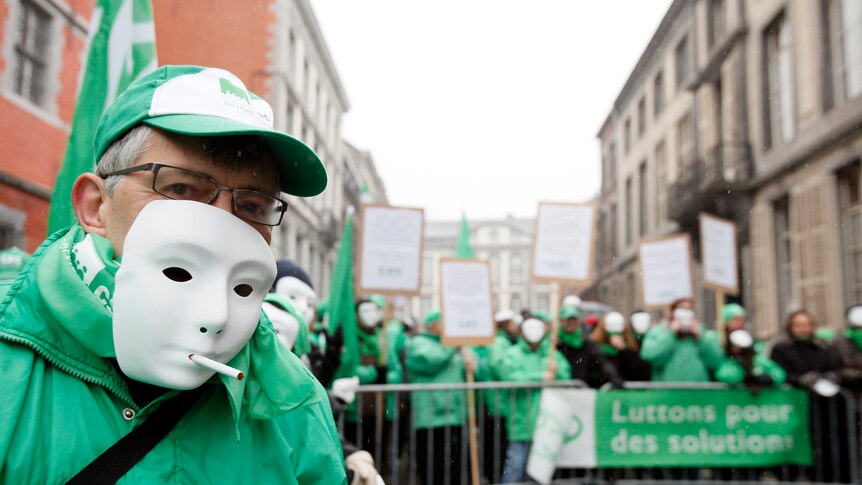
[{"x1": 497, "y1": 338, "x2": 572, "y2": 441}]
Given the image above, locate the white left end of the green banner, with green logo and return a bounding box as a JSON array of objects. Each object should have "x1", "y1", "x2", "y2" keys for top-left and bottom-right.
[{"x1": 527, "y1": 389, "x2": 596, "y2": 484}]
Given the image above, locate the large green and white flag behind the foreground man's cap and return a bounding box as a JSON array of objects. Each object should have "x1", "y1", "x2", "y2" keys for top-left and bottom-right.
[{"x1": 48, "y1": 0, "x2": 158, "y2": 234}]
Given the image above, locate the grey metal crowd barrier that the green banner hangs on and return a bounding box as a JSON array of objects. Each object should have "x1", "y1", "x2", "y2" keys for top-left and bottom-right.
[{"x1": 337, "y1": 380, "x2": 862, "y2": 485}]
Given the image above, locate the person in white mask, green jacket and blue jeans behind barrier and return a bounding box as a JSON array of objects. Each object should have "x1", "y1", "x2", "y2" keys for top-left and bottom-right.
[{"x1": 498, "y1": 317, "x2": 572, "y2": 483}]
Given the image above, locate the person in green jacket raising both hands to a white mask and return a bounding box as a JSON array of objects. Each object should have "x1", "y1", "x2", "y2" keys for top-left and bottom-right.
[{"x1": 640, "y1": 299, "x2": 723, "y2": 382}]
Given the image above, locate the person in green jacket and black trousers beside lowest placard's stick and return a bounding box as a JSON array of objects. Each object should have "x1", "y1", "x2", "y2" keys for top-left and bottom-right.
[{"x1": 405, "y1": 310, "x2": 475, "y2": 484}]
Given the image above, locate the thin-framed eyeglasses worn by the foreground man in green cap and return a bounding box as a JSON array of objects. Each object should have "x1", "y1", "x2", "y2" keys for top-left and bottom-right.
[{"x1": 98, "y1": 163, "x2": 287, "y2": 226}]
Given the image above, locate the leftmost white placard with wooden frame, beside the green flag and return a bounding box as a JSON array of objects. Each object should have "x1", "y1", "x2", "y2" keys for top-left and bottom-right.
[{"x1": 358, "y1": 205, "x2": 423, "y2": 295}]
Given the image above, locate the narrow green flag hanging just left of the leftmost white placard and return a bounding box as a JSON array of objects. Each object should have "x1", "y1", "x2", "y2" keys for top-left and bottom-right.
[{"x1": 329, "y1": 211, "x2": 359, "y2": 377}]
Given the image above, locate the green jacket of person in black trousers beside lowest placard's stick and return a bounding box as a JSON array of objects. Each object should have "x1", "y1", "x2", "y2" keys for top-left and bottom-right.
[{"x1": 405, "y1": 333, "x2": 465, "y2": 429}]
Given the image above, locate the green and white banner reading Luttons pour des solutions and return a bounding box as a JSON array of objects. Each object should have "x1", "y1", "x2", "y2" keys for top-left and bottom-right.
[{"x1": 527, "y1": 389, "x2": 813, "y2": 483}]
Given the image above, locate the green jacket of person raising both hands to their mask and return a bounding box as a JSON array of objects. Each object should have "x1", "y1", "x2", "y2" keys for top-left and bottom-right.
[{"x1": 640, "y1": 325, "x2": 724, "y2": 382}]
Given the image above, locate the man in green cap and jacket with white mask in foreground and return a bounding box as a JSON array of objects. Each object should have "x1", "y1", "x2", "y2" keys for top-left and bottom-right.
[{"x1": 0, "y1": 66, "x2": 346, "y2": 484}]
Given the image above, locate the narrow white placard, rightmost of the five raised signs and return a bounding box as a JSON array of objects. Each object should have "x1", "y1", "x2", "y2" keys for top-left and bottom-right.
[{"x1": 700, "y1": 213, "x2": 739, "y2": 295}]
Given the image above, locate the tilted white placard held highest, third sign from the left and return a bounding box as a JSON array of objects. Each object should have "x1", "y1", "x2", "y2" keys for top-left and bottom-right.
[{"x1": 533, "y1": 202, "x2": 596, "y2": 285}]
